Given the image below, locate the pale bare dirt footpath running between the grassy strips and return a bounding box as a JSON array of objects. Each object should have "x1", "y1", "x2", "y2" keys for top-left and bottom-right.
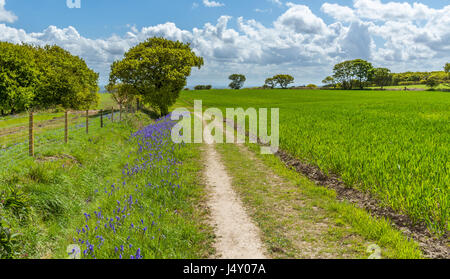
[{"x1": 197, "y1": 112, "x2": 266, "y2": 259}]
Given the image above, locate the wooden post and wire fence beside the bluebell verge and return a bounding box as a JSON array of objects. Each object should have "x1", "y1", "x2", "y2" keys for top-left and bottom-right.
[{"x1": 0, "y1": 107, "x2": 130, "y2": 172}]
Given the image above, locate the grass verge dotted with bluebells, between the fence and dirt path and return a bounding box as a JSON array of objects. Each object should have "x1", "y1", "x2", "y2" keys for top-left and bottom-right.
[{"x1": 0, "y1": 113, "x2": 212, "y2": 259}]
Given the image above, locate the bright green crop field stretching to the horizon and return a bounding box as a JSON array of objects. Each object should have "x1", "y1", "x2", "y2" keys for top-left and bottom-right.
[{"x1": 181, "y1": 90, "x2": 450, "y2": 233}]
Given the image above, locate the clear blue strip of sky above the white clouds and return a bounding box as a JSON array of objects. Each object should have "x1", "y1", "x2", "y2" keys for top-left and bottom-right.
[{"x1": 6, "y1": 0, "x2": 444, "y2": 38}]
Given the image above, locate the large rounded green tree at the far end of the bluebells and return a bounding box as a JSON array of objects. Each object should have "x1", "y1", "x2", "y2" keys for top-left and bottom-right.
[{"x1": 109, "y1": 38, "x2": 203, "y2": 115}]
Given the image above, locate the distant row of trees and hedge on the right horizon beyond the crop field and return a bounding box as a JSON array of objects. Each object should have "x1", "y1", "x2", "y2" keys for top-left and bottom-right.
[{"x1": 322, "y1": 59, "x2": 450, "y2": 89}]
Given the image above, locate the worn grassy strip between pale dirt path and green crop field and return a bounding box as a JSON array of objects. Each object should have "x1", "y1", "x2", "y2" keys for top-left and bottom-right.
[{"x1": 217, "y1": 144, "x2": 422, "y2": 259}]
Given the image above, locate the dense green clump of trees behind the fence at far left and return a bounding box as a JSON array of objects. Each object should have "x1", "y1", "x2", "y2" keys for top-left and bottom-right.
[{"x1": 0, "y1": 42, "x2": 99, "y2": 115}]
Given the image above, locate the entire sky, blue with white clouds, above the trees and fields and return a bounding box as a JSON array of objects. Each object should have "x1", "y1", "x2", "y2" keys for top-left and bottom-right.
[{"x1": 0, "y1": 0, "x2": 450, "y2": 86}]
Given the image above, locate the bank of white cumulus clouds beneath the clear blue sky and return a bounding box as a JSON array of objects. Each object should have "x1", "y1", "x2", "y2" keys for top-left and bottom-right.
[{"x1": 0, "y1": 0, "x2": 450, "y2": 85}]
